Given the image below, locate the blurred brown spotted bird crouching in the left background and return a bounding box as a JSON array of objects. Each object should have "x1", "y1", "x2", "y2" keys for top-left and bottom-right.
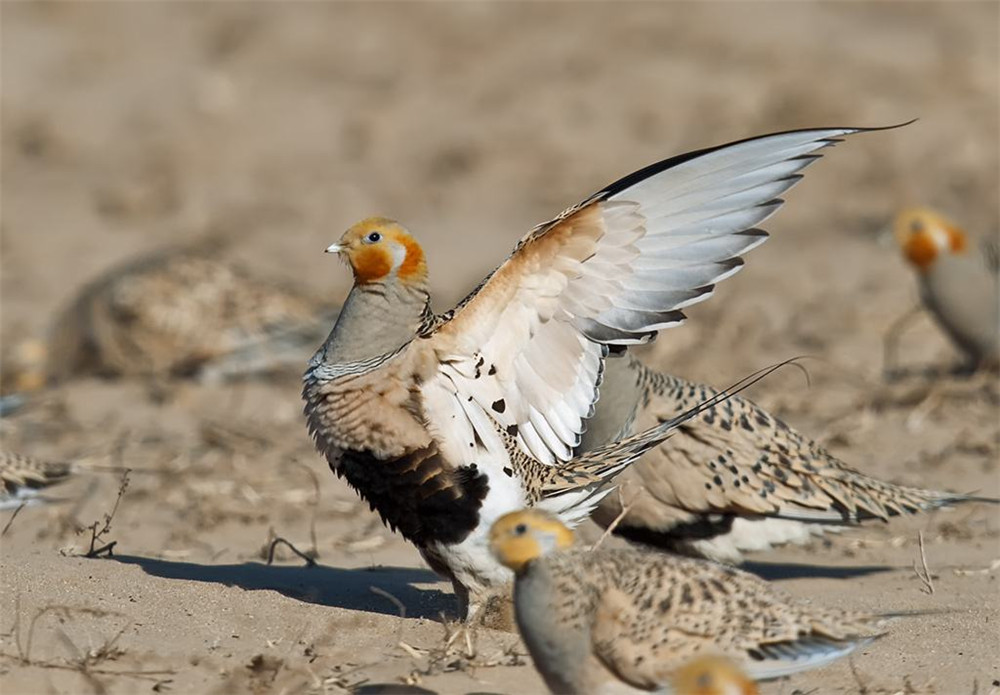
[{"x1": 36, "y1": 241, "x2": 335, "y2": 383}]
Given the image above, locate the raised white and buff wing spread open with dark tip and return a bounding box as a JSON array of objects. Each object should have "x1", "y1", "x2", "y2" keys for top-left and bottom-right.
[{"x1": 424, "y1": 128, "x2": 892, "y2": 463}]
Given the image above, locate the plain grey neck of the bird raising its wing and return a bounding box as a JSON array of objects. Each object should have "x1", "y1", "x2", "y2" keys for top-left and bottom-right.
[{"x1": 313, "y1": 282, "x2": 428, "y2": 366}]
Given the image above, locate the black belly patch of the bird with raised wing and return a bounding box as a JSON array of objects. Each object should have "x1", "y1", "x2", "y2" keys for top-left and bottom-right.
[{"x1": 330, "y1": 451, "x2": 489, "y2": 546}]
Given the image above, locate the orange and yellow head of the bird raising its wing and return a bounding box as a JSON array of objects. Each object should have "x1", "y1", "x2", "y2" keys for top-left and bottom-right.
[{"x1": 326, "y1": 217, "x2": 427, "y2": 285}]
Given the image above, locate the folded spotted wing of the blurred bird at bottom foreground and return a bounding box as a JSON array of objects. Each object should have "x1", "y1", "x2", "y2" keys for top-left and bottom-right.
[{"x1": 591, "y1": 554, "x2": 884, "y2": 689}]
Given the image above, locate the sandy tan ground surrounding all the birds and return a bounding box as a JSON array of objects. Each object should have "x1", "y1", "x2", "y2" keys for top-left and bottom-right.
[{"x1": 0, "y1": 2, "x2": 1000, "y2": 693}]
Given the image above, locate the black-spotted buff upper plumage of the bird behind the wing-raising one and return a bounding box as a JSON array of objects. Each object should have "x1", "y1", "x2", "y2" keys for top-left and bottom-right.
[{"x1": 584, "y1": 358, "x2": 984, "y2": 546}]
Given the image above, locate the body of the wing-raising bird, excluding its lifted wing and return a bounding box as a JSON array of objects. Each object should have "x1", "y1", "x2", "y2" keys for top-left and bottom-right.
[{"x1": 304, "y1": 223, "x2": 712, "y2": 609}]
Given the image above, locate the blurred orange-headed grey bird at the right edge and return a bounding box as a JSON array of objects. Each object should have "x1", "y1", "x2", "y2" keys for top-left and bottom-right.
[{"x1": 894, "y1": 208, "x2": 1000, "y2": 368}]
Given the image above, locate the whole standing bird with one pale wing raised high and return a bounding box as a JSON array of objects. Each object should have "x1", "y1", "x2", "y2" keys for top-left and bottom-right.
[{"x1": 303, "y1": 128, "x2": 896, "y2": 616}]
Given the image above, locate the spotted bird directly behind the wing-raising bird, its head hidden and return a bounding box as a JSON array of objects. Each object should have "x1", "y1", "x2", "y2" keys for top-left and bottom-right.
[{"x1": 577, "y1": 355, "x2": 996, "y2": 563}]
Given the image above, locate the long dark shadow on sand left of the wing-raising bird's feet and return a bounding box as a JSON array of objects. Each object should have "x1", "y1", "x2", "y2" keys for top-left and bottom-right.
[{"x1": 112, "y1": 555, "x2": 458, "y2": 620}]
